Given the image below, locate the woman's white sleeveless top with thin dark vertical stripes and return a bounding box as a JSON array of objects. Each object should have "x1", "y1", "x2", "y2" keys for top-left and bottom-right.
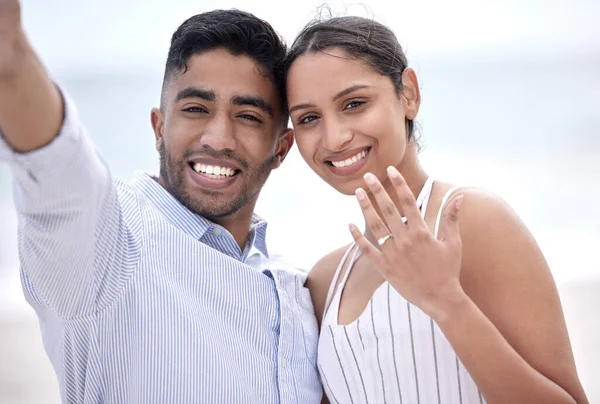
[{"x1": 318, "y1": 180, "x2": 485, "y2": 404}]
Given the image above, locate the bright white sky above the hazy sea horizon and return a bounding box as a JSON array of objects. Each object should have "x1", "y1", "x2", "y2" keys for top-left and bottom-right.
[{"x1": 23, "y1": 0, "x2": 600, "y2": 71}]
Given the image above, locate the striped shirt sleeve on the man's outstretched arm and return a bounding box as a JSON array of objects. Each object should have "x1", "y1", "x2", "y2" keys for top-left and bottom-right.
[{"x1": 0, "y1": 89, "x2": 139, "y2": 318}]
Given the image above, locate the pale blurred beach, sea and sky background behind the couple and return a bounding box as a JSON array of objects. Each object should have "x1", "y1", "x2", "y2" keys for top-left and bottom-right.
[{"x1": 0, "y1": 0, "x2": 600, "y2": 404}]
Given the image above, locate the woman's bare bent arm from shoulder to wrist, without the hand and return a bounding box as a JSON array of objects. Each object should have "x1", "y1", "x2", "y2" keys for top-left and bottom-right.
[{"x1": 435, "y1": 190, "x2": 587, "y2": 403}]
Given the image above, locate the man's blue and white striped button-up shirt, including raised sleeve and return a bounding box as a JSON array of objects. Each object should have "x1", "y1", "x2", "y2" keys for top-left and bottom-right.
[{"x1": 0, "y1": 94, "x2": 322, "y2": 404}]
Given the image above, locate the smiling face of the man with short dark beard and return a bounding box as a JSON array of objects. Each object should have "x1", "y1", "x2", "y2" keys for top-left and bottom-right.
[{"x1": 152, "y1": 49, "x2": 293, "y2": 221}]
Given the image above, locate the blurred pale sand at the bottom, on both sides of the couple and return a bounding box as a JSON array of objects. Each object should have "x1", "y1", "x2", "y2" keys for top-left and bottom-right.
[{"x1": 0, "y1": 279, "x2": 600, "y2": 404}]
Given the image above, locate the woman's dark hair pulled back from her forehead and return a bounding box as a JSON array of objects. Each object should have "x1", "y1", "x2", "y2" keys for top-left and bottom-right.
[{"x1": 283, "y1": 16, "x2": 416, "y2": 141}]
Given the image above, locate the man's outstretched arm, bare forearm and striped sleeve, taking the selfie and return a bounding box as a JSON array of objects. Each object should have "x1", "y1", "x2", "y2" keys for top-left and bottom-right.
[{"x1": 0, "y1": 0, "x2": 140, "y2": 318}]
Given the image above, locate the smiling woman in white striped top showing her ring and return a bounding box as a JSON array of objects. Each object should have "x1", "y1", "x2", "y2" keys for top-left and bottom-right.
[{"x1": 285, "y1": 17, "x2": 587, "y2": 404}]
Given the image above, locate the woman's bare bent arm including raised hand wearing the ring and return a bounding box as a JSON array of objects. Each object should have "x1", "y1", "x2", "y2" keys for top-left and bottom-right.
[{"x1": 352, "y1": 167, "x2": 588, "y2": 404}]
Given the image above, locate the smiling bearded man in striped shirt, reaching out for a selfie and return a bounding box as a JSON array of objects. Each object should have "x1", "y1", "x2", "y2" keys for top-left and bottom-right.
[{"x1": 0, "y1": 0, "x2": 322, "y2": 404}]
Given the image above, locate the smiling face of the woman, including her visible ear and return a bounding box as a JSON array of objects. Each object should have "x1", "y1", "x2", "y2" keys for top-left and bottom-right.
[{"x1": 287, "y1": 48, "x2": 419, "y2": 195}]
